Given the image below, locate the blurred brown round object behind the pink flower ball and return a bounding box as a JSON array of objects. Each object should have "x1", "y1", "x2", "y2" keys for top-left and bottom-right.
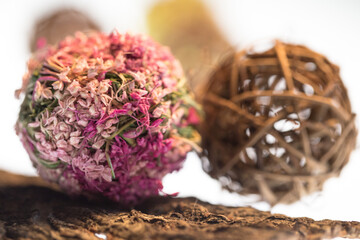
[{"x1": 30, "y1": 9, "x2": 100, "y2": 52}]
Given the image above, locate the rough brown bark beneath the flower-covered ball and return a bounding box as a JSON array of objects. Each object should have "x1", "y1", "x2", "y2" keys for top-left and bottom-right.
[{"x1": 0, "y1": 171, "x2": 360, "y2": 240}]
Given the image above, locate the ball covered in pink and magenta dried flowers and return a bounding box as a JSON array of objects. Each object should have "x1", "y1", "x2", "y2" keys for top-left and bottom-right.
[{"x1": 17, "y1": 31, "x2": 199, "y2": 205}]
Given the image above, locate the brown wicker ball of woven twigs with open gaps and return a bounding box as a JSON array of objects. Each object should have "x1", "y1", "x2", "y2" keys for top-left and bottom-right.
[{"x1": 201, "y1": 41, "x2": 357, "y2": 205}]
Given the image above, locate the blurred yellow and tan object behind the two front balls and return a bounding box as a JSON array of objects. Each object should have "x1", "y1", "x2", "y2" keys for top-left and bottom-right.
[{"x1": 148, "y1": 0, "x2": 232, "y2": 97}]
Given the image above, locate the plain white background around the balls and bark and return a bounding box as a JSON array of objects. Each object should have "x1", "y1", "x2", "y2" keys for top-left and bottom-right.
[{"x1": 0, "y1": 0, "x2": 360, "y2": 235}]
